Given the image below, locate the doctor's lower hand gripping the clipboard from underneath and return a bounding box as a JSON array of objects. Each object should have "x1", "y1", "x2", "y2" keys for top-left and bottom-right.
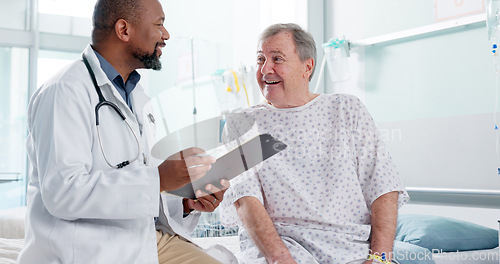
[{"x1": 184, "y1": 180, "x2": 230, "y2": 212}]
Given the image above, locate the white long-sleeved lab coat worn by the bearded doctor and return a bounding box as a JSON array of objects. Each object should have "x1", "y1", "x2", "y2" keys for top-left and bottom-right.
[{"x1": 18, "y1": 45, "x2": 199, "y2": 264}]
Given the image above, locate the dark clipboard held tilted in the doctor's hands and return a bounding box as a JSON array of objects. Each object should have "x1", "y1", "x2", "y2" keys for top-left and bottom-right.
[{"x1": 167, "y1": 134, "x2": 287, "y2": 199}]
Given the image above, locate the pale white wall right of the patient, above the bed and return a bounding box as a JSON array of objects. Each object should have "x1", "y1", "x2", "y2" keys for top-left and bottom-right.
[{"x1": 326, "y1": 0, "x2": 500, "y2": 224}]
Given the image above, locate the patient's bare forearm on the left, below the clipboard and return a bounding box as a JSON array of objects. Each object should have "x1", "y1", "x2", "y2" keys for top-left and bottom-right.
[{"x1": 234, "y1": 196, "x2": 296, "y2": 264}]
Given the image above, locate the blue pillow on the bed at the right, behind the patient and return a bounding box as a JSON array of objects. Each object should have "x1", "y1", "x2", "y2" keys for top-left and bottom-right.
[{"x1": 395, "y1": 215, "x2": 498, "y2": 253}]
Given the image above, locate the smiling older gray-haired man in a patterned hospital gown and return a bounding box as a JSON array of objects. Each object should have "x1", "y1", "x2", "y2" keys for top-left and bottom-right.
[{"x1": 221, "y1": 24, "x2": 408, "y2": 264}]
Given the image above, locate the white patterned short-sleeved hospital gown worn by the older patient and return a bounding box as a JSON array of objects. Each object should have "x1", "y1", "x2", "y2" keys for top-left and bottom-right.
[{"x1": 221, "y1": 94, "x2": 409, "y2": 264}]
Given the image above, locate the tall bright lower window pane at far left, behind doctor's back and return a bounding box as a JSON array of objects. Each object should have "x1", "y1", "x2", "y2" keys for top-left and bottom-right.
[{"x1": 0, "y1": 47, "x2": 29, "y2": 209}]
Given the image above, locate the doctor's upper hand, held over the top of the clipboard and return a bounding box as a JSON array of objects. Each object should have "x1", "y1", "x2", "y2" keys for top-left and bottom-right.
[{"x1": 158, "y1": 147, "x2": 215, "y2": 192}]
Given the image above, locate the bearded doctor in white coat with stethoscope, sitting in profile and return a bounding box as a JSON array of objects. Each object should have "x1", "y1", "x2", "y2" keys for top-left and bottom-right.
[{"x1": 18, "y1": 0, "x2": 229, "y2": 264}]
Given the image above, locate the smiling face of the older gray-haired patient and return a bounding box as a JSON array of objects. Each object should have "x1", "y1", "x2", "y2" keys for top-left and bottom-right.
[{"x1": 257, "y1": 31, "x2": 312, "y2": 108}]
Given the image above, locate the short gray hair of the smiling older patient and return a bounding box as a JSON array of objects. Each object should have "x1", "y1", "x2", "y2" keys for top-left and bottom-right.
[{"x1": 259, "y1": 23, "x2": 317, "y2": 81}]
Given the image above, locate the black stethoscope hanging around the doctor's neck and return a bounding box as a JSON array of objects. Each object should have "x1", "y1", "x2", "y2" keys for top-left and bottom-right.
[{"x1": 82, "y1": 54, "x2": 141, "y2": 169}]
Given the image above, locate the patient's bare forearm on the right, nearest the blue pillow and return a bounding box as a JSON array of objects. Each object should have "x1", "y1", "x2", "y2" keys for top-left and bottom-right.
[{"x1": 367, "y1": 192, "x2": 398, "y2": 263}]
